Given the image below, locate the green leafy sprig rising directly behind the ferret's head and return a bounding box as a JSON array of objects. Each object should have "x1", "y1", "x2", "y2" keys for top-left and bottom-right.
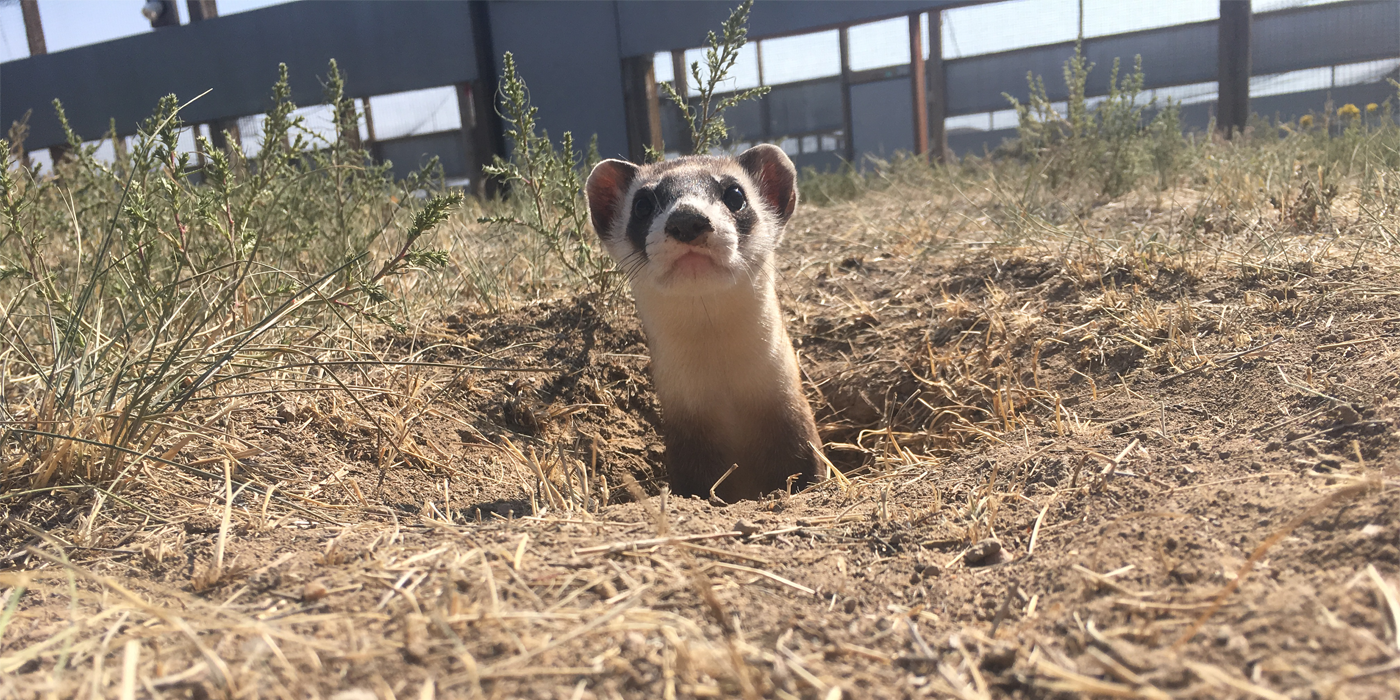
[{"x1": 661, "y1": 0, "x2": 769, "y2": 154}]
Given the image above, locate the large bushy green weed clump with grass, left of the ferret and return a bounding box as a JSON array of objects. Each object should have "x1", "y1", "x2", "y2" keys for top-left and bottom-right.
[{"x1": 0, "y1": 62, "x2": 462, "y2": 496}]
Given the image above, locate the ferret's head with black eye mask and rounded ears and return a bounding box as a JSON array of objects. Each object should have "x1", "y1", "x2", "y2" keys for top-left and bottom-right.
[{"x1": 585, "y1": 144, "x2": 797, "y2": 295}]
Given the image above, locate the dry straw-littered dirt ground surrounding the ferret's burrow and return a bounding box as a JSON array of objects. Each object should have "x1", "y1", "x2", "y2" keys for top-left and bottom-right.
[{"x1": 0, "y1": 193, "x2": 1400, "y2": 700}]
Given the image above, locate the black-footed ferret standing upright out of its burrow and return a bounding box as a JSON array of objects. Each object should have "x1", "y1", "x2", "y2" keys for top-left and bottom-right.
[{"x1": 587, "y1": 146, "x2": 826, "y2": 501}]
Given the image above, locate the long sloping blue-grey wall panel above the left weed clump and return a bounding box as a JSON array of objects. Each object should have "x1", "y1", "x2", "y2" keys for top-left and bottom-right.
[{"x1": 0, "y1": 0, "x2": 478, "y2": 148}]
